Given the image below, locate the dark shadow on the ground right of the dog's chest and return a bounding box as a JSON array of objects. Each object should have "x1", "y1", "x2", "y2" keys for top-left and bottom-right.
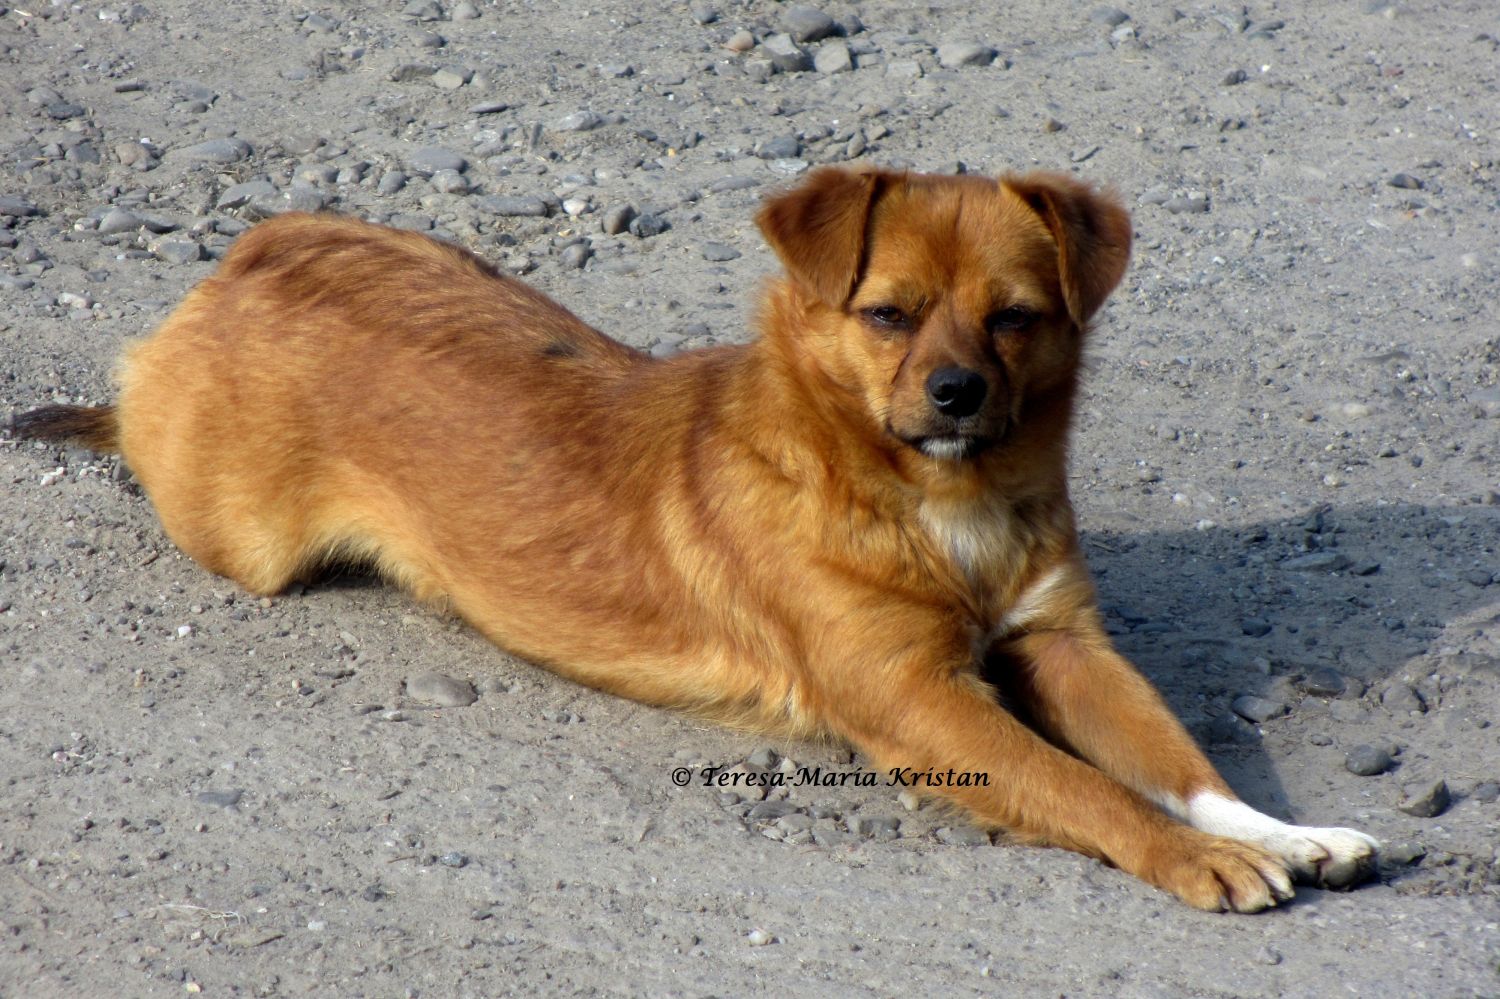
[{"x1": 1062, "y1": 504, "x2": 1500, "y2": 819}]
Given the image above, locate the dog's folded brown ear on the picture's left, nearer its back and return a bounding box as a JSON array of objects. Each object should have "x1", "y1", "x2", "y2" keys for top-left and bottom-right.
[{"x1": 755, "y1": 167, "x2": 888, "y2": 306}]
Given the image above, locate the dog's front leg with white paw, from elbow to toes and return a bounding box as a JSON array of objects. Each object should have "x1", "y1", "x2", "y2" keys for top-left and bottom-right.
[{"x1": 999, "y1": 615, "x2": 1379, "y2": 888}]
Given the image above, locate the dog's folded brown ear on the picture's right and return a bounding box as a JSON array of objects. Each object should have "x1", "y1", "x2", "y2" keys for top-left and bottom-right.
[{"x1": 1004, "y1": 173, "x2": 1131, "y2": 329}]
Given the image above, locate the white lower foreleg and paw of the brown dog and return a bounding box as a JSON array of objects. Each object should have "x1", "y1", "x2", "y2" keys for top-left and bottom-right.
[{"x1": 1184, "y1": 791, "x2": 1380, "y2": 888}]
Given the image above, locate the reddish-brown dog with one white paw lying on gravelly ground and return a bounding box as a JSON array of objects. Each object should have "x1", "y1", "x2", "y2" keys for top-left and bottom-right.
[{"x1": 15, "y1": 167, "x2": 1377, "y2": 912}]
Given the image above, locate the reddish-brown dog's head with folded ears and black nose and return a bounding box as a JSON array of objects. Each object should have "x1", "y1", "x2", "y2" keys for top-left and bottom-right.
[{"x1": 756, "y1": 168, "x2": 1131, "y2": 462}]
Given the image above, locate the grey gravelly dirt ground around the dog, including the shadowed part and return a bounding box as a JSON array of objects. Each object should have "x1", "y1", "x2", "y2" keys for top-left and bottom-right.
[{"x1": 0, "y1": 0, "x2": 1500, "y2": 998}]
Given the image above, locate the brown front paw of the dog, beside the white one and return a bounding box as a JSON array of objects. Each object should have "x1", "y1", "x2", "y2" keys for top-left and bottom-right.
[{"x1": 1139, "y1": 830, "x2": 1293, "y2": 912}]
